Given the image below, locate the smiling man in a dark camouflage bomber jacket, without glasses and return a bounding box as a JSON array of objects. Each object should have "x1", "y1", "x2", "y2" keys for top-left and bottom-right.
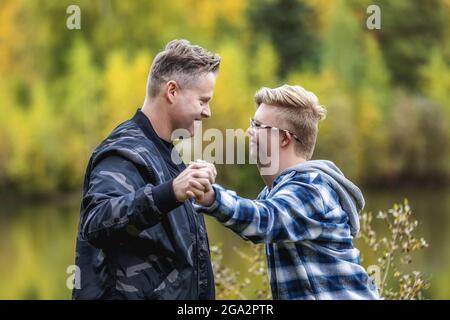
[{"x1": 73, "y1": 40, "x2": 220, "y2": 299}]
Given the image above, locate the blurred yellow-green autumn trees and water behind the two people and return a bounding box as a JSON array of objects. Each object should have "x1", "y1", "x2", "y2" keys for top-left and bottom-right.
[{"x1": 0, "y1": 0, "x2": 450, "y2": 299}]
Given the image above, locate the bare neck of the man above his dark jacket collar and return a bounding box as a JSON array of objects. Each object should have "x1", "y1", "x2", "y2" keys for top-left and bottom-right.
[{"x1": 141, "y1": 97, "x2": 173, "y2": 142}]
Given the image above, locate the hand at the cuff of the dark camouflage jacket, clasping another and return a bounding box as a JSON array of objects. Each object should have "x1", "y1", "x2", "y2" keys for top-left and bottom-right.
[{"x1": 173, "y1": 161, "x2": 217, "y2": 202}]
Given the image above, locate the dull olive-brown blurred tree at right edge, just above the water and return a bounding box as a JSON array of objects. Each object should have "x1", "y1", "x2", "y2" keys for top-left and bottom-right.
[{"x1": 389, "y1": 91, "x2": 448, "y2": 182}]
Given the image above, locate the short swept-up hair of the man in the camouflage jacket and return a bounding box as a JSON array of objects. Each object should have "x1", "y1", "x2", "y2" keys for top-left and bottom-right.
[{"x1": 147, "y1": 39, "x2": 220, "y2": 97}]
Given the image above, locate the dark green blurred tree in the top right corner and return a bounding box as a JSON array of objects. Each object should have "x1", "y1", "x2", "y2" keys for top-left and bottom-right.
[{"x1": 375, "y1": 0, "x2": 450, "y2": 89}]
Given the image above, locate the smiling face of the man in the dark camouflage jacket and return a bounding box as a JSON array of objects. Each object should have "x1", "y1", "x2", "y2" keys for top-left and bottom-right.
[{"x1": 172, "y1": 72, "x2": 216, "y2": 136}]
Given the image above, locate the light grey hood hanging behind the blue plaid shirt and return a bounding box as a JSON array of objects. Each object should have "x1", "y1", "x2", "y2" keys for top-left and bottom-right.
[{"x1": 281, "y1": 160, "x2": 365, "y2": 236}]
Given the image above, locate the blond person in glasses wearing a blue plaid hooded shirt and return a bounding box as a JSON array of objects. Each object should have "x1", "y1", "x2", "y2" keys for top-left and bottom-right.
[{"x1": 192, "y1": 85, "x2": 378, "y2": 299}]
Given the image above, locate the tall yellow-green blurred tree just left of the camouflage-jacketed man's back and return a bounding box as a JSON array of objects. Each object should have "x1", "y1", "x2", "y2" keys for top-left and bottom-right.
[{"x1": 58, "y1": 37, "x2": 103, "y2": 188}]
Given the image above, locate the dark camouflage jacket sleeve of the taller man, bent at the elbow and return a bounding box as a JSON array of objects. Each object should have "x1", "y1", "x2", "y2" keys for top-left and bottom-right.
[{"x1": 80, "y1": 156, "x2": 182, "y2": 247}]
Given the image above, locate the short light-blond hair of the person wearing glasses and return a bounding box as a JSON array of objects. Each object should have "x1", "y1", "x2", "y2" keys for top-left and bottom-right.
[{"x1": 255, "y1": 84, "x2": 326, "y2": 160}]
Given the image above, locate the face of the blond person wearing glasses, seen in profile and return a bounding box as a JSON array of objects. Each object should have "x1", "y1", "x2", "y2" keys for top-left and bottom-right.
[{"x1": 247, "y1": 103, "x2": 280, "y2": 170}]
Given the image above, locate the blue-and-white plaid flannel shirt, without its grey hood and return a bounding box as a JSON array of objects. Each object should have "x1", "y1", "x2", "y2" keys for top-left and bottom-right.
[{"x1": 196, "y1": 172, "x2": 379, "y2": 299}]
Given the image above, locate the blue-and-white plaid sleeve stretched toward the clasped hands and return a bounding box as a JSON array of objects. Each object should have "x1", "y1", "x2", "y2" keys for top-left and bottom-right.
[{"x1": 196, "y1": 180, "x2": 324, "y2": 243}]
